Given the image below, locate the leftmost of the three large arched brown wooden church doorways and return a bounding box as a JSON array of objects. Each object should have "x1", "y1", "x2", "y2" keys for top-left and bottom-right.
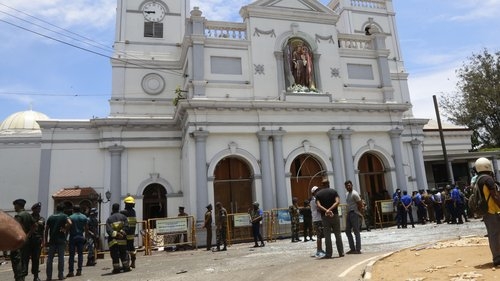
[{"x1": 214, "y1": 157, "x2": 253, "y2": 214}]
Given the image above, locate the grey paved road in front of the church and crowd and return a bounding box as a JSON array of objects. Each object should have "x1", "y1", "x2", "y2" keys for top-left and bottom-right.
[{"x1": 0, "y1": 220, "x2": 486, "y2": 281}]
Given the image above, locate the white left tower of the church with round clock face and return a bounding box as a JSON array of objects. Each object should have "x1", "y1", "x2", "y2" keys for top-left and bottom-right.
[{"x1": 110, "y1": 0, "x2": 190, "y2": 117}]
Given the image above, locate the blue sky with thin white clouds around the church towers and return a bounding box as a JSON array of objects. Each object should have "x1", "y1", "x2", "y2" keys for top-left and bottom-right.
[{"x1": 0, "y1": 0, "x2": 500, "y2": 121}]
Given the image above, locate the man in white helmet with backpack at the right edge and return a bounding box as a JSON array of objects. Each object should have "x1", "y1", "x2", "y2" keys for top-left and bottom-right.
[{"x1": 474, "y1": 157, "x2": 500, "y2": 266}]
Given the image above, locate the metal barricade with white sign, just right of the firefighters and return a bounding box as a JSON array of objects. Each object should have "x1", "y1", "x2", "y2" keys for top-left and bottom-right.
[{"x1": 141, "y1": 216, "x2": 197, "y2": 255}]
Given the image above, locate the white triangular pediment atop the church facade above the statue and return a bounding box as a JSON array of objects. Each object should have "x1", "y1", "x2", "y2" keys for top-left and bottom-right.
[{"x1": 240, "y1": 0, "x2": 338, "y2": 24}]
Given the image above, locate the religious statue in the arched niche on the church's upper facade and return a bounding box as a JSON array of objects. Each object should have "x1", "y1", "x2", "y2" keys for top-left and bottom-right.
[{"x1": 285, "y1": 38, "x2": 316, "y2": 90}]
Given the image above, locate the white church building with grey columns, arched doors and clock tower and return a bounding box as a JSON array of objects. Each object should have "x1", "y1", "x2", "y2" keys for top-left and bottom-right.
[{"x1": 0, "y1": 0, "x2": 478, "y2": 221}]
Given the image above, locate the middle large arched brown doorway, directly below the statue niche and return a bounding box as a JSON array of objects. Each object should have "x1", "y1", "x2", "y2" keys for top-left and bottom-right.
[{"x1": 290, "y1": 154, "x2": 325, "y2": 206}]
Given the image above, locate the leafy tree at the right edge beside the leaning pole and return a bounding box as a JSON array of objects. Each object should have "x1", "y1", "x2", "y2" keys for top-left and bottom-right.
[{"x1": 440, "y1": 49, "x2": 500, "y2": 147}]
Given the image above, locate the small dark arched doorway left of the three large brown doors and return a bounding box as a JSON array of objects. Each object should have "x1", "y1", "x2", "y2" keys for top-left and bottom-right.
[{"x1": 142, "y1": 183, "x2": 167, "y2": 221}]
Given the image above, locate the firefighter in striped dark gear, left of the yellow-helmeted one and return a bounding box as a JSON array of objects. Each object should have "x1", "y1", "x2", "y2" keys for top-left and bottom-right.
[{"x1": 106, "y1": 203, "x2": 130, "y2": 274}]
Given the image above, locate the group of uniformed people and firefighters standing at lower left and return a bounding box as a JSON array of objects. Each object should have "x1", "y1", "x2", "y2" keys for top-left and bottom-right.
[{"x1": 3, "y1": 196, "x2": 136, "y2": 281}]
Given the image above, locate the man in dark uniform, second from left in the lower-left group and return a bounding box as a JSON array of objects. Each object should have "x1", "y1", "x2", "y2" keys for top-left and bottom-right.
[{"x1": 25, "y1": 202, "x2": 45, "y2": 281}]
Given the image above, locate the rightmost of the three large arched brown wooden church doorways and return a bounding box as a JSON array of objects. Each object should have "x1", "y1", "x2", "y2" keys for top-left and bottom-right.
[{"x1": 358, "y1": 152, "x2": 386, "y2": 201}]
